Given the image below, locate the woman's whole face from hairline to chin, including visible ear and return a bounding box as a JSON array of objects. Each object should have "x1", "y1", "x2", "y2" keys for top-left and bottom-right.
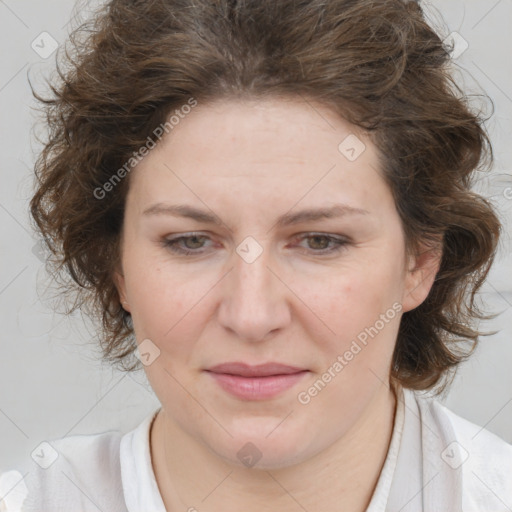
[{"x1": 116, "y1": 99, "x2": 438, "y2": 468}]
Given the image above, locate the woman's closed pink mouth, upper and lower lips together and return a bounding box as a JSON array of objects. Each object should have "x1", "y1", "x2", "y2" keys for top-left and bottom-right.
[{"x1": 205, "y1": 362, "x2": 309, "y2": 400}]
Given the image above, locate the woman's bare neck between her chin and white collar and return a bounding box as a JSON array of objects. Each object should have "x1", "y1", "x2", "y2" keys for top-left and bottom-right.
[{"x1": 151, "y1": 386, "x2": 396, "y2": 512}]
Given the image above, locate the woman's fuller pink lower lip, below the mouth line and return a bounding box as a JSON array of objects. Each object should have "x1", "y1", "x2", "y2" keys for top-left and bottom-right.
[{"x1": 208, "y1": 371, "x2": 309, "y2": 400}]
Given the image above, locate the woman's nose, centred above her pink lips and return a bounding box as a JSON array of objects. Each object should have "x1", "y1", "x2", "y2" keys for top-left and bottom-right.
[{"x1": 218, "y1": 244, "x2": 292, "y2": 342}]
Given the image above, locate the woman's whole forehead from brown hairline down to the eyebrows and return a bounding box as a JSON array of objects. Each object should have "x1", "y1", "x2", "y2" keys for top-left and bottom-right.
[{"x1": 126, "y1": 99, "x2": 389, "y2": 220}]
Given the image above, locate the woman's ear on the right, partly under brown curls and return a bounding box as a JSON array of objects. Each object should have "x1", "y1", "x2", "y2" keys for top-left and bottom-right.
[{"x1": 402, "y1": 237, "x2": 443, "y2": 312}]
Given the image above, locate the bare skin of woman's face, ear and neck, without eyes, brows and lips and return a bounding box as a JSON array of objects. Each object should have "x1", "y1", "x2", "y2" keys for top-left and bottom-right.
[{"x1": 115, "y1": 98, "x2": 440, "y2": 512}]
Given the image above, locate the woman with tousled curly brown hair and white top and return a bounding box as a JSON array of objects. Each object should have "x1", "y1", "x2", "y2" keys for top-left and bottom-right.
[{"x1": 2, "y1": 0, "x2": 512, "y2": 512}]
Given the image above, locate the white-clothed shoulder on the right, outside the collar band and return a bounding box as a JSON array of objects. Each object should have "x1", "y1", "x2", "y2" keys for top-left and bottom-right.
[{"x1": 415, "y1": 394, "x2": 512, "y2": 511}]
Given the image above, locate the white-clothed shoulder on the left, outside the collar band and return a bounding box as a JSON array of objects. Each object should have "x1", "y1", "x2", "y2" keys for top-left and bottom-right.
[{"x1": 2, "y1": 431, "x2": 126, "y2": 512}]
